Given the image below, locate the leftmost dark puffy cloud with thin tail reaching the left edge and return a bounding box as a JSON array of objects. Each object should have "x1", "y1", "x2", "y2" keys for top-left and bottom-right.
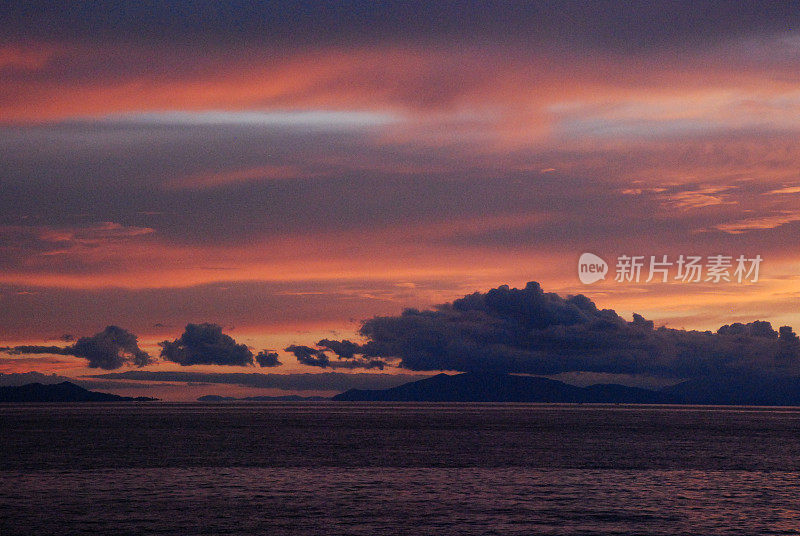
[{"x1": 0, "y1": 326, "x2": 154, "y2": 370}]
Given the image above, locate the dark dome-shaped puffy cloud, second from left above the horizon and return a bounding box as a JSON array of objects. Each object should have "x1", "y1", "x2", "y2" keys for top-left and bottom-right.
[{"x1": 158, "y1": 323, "x2": 262, "y2": 367}]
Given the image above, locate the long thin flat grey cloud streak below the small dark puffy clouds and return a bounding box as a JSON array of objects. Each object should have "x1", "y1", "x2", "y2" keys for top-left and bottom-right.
[{"x1": 90, "y1": 370, "x2": 428, "y2": 392}]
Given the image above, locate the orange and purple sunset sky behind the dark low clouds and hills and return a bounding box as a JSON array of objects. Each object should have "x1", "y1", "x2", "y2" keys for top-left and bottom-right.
[{"x1": 0, "y1": 0, "x2": 800, "y2": 400}]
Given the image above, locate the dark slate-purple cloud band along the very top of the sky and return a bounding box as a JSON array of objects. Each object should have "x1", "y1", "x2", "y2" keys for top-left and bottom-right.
[{"x1": 0, "y1": 0, "x2": 800, "y2": 49}]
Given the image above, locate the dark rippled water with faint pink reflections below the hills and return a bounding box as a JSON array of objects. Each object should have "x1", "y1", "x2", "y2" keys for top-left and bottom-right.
[{"x1": 0, "y1": 403, "x2": 800, "y2": 536}]
